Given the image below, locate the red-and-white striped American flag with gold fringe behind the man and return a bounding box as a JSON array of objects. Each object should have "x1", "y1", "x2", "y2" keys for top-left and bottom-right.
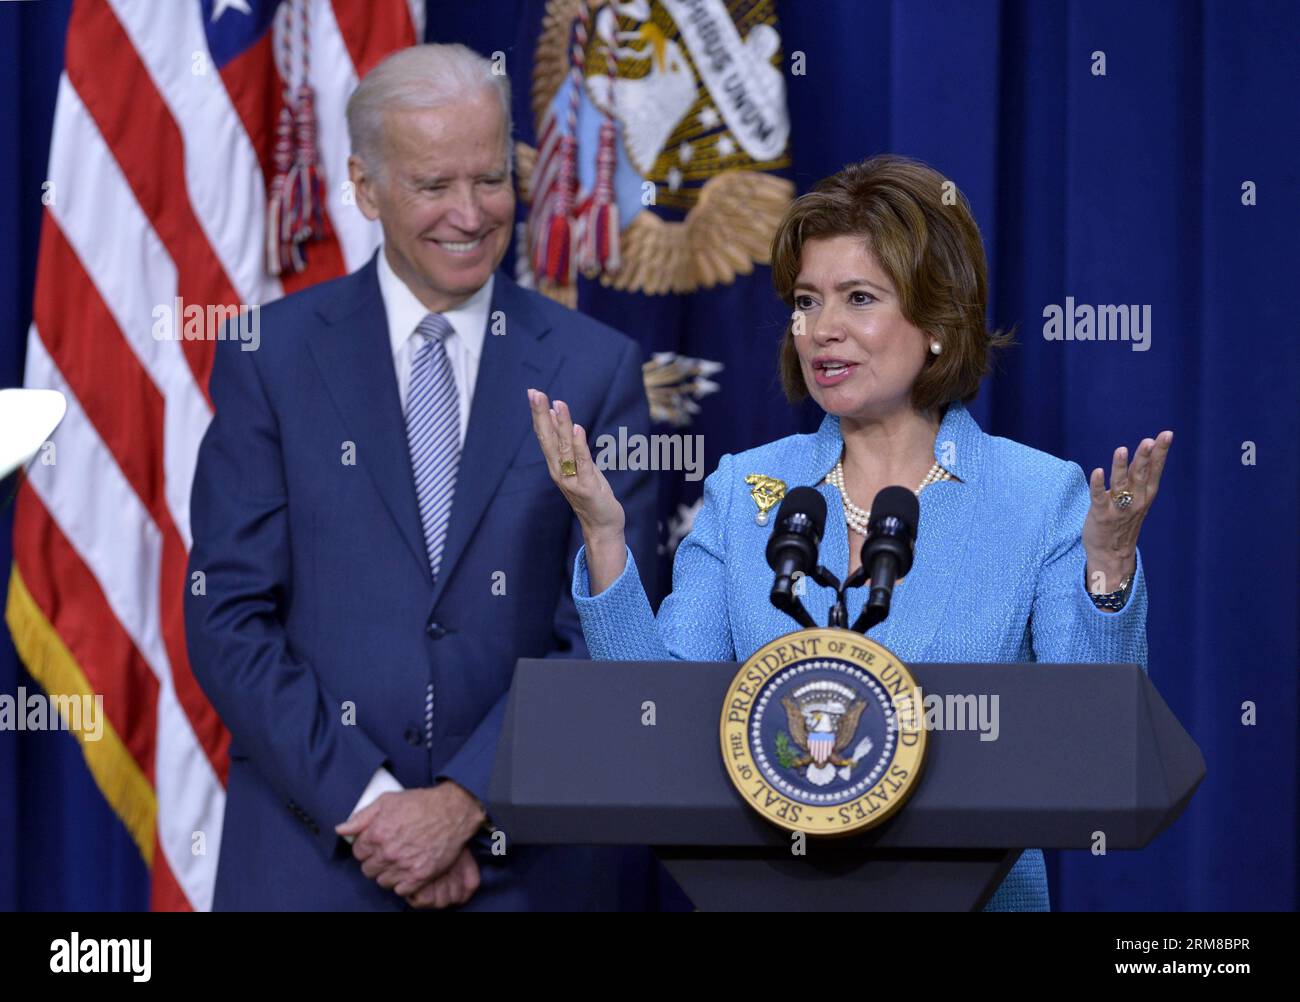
[{"x1": 5, "y1": 0, "x2": 424, "y2": 910}]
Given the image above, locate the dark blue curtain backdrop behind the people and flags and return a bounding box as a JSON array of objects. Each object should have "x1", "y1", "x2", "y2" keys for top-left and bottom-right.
[{"x1": 0, "y1": 0, "x2": 1300, "y2": 910}]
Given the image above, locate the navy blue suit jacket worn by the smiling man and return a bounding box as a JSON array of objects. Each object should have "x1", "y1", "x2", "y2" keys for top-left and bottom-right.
[{"x1": 186, "y1": 259, "x2": 655, "y2": 910}]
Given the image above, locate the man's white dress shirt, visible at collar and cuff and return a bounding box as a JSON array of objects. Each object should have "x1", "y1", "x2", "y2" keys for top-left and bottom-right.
[{"x1": 347, "y1": 247, "x2": 495, "y2": 842}]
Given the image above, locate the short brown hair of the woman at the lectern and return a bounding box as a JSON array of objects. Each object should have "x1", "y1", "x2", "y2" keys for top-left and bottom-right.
[{"x1": 772, "y1": 156, "x2": 1011, "y2": 411}]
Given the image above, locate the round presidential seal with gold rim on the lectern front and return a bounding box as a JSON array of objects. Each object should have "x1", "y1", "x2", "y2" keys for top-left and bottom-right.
[{"x1": 722, "y1": 629, "x2": 926, "y2": 836}]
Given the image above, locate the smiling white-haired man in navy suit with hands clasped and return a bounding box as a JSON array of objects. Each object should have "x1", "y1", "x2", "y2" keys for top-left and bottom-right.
[{"x1": 186, "y1": 45, "x2": 655, "y2": 910}]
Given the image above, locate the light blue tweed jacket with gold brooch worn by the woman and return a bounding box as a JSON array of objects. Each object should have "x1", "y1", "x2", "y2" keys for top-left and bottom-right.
[{"x1": 573, "y1": 403, "x2": 1147, "y2": 911}]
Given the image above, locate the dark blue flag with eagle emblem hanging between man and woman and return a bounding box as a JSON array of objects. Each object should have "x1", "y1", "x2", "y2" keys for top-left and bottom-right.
[{"x1": 516, "y1": 0, "x2": 797, "y2": 584}]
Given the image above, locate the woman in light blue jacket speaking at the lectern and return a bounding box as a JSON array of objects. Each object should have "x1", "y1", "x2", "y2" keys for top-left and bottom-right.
[{"x1": 528, "y1": 156, "x2": 1174, "y2": 911}]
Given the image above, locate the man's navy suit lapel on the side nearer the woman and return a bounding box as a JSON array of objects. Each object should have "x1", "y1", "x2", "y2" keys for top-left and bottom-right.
[{"x1": 428, "y1": 272, "x2": 562, "y2": 604}]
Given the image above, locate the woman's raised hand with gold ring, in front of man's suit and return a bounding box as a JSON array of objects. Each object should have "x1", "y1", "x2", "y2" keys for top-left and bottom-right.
[{"x1": 528, "y1": 390, "x2": 624, "y2": 548}]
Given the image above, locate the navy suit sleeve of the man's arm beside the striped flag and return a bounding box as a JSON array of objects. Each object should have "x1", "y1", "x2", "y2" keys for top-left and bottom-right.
[{"x1": 185, "y1": 340, "x2": 385, "y2": 854}]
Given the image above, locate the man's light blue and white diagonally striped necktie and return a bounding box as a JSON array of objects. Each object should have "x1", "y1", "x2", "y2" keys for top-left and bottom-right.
[{"x1": 407, "y1": 313, "x2": 460, "y2": 580}]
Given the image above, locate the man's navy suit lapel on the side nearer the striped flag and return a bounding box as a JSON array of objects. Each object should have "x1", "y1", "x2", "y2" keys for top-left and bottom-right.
[{"x1": 308, "y1": 256, "x2": 429, "y2": 577}]
